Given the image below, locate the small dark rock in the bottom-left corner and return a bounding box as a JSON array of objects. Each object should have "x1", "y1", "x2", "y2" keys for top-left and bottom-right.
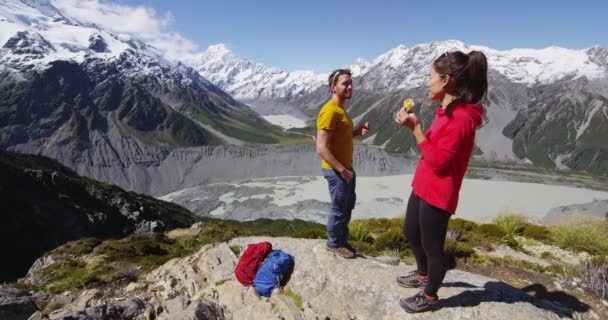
[{"x1": 0, "y1": 288, "x2": 39, "y2": 320}]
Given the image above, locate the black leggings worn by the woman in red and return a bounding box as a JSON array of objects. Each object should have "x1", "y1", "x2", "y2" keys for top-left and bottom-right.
[{"x1": 403, "y1": 191, "x2": 451, "y2": 297}]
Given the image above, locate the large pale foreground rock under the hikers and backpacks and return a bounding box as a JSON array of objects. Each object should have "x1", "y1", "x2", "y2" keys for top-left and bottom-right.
[{"x1": 141, "y1": 237, "x2": 575, "y2": 320}]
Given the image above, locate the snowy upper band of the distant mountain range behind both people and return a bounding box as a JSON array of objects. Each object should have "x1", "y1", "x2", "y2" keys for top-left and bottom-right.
[{"x1": 184, "y1": 40, "x2": 608, "y2": 101}]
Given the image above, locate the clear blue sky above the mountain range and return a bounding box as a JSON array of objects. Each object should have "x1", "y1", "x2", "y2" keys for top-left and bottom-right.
[{"x1": 102, "y1": 0, "x2": 608, "y2": 72}]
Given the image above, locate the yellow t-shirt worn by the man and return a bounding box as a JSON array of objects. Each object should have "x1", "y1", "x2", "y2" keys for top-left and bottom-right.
[{"x1": 317, "y1": 100, "x2": 353, "y2": 169}]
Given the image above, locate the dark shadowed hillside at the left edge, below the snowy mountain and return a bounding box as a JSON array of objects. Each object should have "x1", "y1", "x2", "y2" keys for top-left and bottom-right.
[{"x1": 0, "y1": 150, "x2": 197, "y2": 281}]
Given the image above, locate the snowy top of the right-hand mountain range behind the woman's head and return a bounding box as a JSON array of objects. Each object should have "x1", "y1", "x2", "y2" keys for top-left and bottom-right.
[{"x1": 354, "y1": 40, "x2": 608, "y2": 90}]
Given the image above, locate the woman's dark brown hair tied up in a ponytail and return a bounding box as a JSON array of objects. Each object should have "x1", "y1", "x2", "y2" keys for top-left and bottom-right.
[{"x1": 433, "y1": 51, "x2": 488, "y2": 107}]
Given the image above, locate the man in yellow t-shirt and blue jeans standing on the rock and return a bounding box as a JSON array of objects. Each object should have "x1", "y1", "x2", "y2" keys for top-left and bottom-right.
[{"x1": 317, "y1": 69, "x2": 369, "y2": 259}]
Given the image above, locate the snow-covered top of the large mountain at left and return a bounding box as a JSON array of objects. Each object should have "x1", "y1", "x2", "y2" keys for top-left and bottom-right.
[{"x1": 0, "y1": 0, "x2": 176, "y2": 73}]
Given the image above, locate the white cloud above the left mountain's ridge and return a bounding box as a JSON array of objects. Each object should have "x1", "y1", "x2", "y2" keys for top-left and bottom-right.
[{"x1": 52, "y1": 0, "x2": 198, "y2": 60}]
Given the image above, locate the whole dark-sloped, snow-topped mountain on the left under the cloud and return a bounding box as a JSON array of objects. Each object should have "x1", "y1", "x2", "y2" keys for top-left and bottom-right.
[{"x1": 0, "y1": 0, "x2": 296, "y2": 185}]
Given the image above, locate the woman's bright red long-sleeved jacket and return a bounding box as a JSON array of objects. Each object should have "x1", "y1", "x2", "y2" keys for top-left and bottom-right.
[{"x1": 412, "y1": 104, "x2": 483, "y2": 214}]
